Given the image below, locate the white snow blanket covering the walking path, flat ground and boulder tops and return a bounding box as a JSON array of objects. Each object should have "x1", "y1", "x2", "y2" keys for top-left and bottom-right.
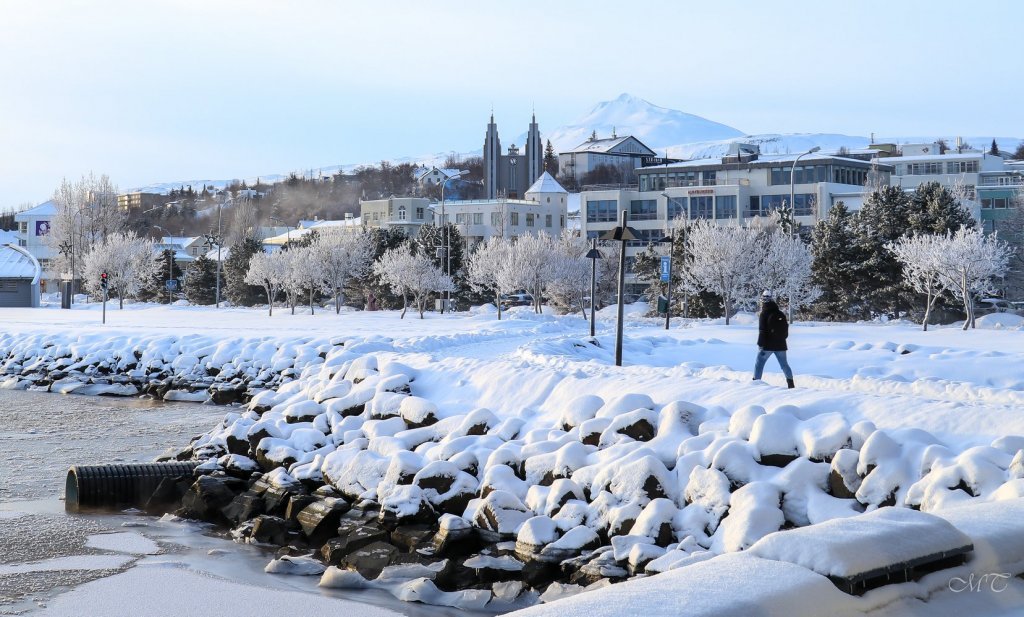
[{"x1": 0, "y1": 305, "x2": 1024, "y2": 615}]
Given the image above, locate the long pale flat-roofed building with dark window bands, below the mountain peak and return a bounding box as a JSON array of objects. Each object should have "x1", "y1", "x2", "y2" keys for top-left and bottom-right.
[{"x1": 581, "y1": 144, "x2": 892, "y2": 293}]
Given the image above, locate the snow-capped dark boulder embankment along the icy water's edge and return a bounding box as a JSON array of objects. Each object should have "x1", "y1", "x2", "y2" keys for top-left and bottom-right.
[{"x1": 6, "y1": 318, "x2": 1024, "y2": 610}]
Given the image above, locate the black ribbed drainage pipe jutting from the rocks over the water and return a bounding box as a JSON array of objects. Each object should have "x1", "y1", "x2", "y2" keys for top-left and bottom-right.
[{"x1": 65, "y1": 461, "x2": 200, "y2": 512}]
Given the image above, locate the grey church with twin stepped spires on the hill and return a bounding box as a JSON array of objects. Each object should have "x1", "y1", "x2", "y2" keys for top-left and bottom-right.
[{"x1": 483, "y1": 113, "x2": 544, "y2": 200}]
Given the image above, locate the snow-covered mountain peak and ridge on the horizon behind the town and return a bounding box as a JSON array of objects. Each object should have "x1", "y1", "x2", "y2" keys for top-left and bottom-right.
[{"x1": 130, "y1": 93, "x2": 1022, "y2": 193}]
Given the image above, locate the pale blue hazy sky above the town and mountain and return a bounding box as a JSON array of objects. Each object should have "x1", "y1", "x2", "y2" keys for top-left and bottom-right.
[{"x1": 0, "y1": 0, "x2": 1024, "y2": 211}]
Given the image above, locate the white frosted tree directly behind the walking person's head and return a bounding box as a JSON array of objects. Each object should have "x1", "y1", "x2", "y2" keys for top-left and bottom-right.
[{"x1": 754, "y1": 229, "x2": 821, "y2": 321}]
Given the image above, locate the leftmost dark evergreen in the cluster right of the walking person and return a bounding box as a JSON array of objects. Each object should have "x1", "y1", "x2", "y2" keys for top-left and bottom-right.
[{"x1": 811, "y1": 202, "x2": 859, "y2": 320}]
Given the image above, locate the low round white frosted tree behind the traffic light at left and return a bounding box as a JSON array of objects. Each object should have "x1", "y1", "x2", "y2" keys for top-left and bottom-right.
[{"x1": 82, "y1": 231, "x2": 161, "y2": 308}]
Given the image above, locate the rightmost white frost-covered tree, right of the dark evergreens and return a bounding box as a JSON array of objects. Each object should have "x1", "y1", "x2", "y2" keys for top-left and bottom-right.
[{"x1": 939, "y1": 227, "x2": 1013, "y2": 329}]
